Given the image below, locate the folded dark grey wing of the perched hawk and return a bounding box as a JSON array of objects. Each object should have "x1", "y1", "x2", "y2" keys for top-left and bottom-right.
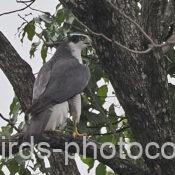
[{"x1": 29, "y1": 59, "x2": 90, "y2": 115}]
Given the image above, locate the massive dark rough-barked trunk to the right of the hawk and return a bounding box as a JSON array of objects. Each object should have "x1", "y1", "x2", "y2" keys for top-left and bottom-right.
[{"x1": 60, "y1": 0, "x2": 175, "y2": 175}]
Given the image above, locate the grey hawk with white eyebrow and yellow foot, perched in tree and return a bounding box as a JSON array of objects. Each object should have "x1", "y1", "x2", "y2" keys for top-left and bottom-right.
[{"x1": 24, "y1": 33, "x2": 90, "y2": 138}]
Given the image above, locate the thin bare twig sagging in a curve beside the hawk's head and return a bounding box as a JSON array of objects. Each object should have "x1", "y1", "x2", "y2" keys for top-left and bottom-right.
[{"x1": 76, "y1": 18, "x2": 152, "y2": 54}]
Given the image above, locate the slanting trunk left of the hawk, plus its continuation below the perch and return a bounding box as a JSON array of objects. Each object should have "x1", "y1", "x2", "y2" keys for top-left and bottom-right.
[{"x1": 0, "y1": 32, "x2": 79, "y2": 175}]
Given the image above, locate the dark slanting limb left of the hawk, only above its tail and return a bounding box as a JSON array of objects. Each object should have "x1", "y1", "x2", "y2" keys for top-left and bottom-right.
[{"x1": 0, "y1": 32, "x2": 35, "y2": 112}]
